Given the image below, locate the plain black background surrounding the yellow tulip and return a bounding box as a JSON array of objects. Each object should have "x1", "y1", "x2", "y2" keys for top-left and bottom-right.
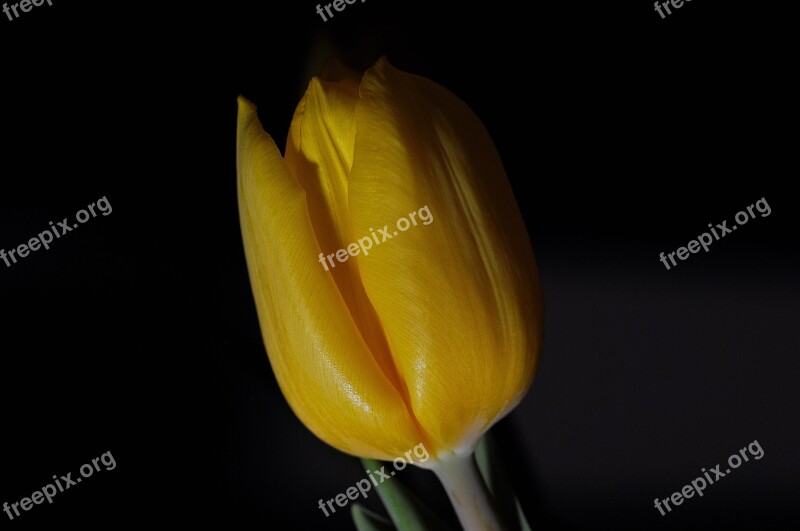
[{"x1": 0, "y1": 0, "x2": 800, "y2": 529}]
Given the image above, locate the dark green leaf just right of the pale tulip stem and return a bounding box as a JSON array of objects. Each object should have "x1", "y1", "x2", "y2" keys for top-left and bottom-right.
[{"x1": 475, "y1": 432, "x2": 530, "y2": 531}]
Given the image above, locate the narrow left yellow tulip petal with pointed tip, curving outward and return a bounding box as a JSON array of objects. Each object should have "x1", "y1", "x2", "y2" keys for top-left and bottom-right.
[{"x1": 237, "y1": 98, "x2": 420, "y2": 459}]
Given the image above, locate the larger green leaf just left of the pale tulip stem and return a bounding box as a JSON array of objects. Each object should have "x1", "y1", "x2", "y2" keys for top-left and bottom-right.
[{"x1": 361, "y1": 459, "x2": 447, "y2": 531}]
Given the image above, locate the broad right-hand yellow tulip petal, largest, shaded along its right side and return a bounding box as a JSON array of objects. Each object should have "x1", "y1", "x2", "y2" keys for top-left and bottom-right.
[{"x1": 349, "y1": 59, "x2": 542, "y2": 453}]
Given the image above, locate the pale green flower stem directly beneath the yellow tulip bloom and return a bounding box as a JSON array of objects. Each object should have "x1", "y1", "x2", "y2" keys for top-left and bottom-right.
[{"x1": 432, "y1": 454, "x2": 505, "y2": 531}]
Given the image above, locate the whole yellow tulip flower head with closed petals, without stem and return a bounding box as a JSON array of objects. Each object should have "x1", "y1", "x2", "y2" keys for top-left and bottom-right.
[{"x1": 237, "y1": 59, "x2": 542, "y2": 468}]
